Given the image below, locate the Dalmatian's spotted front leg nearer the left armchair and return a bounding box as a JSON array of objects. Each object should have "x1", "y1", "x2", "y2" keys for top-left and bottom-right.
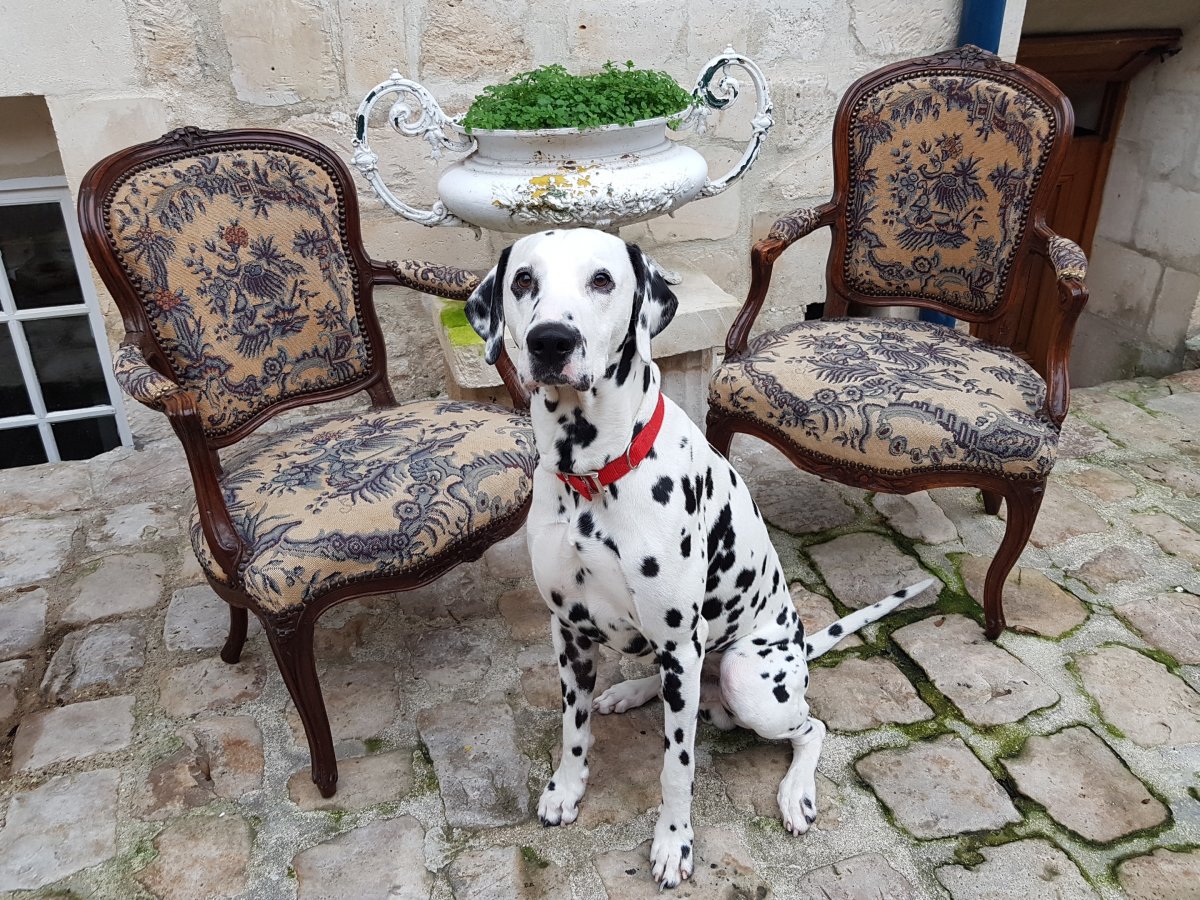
[{"x1": 538, "y1": 616, "x2": 596, "y2": 826}]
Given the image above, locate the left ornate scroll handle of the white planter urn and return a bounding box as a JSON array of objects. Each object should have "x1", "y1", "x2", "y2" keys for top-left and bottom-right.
[{"x1": 352, "y1": 71, "x2": 475, "y2": 228}]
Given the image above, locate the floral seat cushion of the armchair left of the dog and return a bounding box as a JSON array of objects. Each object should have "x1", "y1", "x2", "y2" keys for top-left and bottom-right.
[{"x1": 191, "y1": 401, "x2": 536, "y2": 612}]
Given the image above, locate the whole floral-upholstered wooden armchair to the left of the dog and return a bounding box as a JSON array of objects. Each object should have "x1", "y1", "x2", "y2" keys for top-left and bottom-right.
[{"x1": 79, "y1": 128, "x2": 535, "y2": 797}]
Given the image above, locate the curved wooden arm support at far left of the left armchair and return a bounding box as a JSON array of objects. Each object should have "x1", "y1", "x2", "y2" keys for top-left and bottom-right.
[{"x1": 162, "y1": 389, "x2": 246, "y2": 584}]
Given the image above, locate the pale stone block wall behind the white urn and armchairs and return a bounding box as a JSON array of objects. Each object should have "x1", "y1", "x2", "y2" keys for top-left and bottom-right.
[{"x1": 0, "y1": 0, "x2": 984, "y2": 427}]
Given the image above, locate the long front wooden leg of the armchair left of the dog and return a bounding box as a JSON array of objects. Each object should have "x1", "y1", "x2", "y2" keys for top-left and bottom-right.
[{"x1": 263, "y1": 613, "x2": 337, "y2": 797}]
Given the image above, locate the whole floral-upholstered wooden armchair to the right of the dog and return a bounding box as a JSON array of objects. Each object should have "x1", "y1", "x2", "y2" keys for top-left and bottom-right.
[{"x1": 708, "y1": 46, "x2": 1087, "y2": 637}]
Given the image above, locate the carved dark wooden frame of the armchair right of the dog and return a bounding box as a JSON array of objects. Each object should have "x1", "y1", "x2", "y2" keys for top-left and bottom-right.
[{"x1": 707, "y1": 44, "x2": 1087, "y2": 638}]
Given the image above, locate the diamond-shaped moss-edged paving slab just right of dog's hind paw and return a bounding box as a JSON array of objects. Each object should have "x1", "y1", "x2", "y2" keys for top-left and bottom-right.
[{"x1": 854, "y1": 736, "x2": 1021, "y2": 839}]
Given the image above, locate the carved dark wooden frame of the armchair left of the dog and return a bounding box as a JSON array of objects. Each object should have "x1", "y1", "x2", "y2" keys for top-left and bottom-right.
[{"x1": 78, "y1": 127, "x2": 529, "y2": 797}]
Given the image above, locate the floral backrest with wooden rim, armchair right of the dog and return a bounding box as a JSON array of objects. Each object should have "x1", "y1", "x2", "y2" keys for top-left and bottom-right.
[{"x1": 828, "y1": 46, "x2": 1074, "y2": 322}]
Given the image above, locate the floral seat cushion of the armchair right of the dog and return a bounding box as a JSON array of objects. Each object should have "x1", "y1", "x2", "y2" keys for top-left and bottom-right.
[{"x1": 709, "y1": 318, "x2": 1058, "y2": 479}]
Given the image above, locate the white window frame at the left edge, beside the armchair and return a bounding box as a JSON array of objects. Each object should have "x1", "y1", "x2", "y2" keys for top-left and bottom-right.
[{"x1": 0, "y1": 176, "x2": 133, "y2": 462}]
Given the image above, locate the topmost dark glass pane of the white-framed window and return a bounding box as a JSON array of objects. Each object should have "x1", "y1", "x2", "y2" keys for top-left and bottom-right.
[{"x1": 0, "y1": 203, "x2": 83, "y2": 310}]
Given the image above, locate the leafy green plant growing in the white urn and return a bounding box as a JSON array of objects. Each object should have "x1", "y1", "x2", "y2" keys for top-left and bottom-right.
[{"x1": 462, "y1": 61, "x2": 696, "y2": 132}]
